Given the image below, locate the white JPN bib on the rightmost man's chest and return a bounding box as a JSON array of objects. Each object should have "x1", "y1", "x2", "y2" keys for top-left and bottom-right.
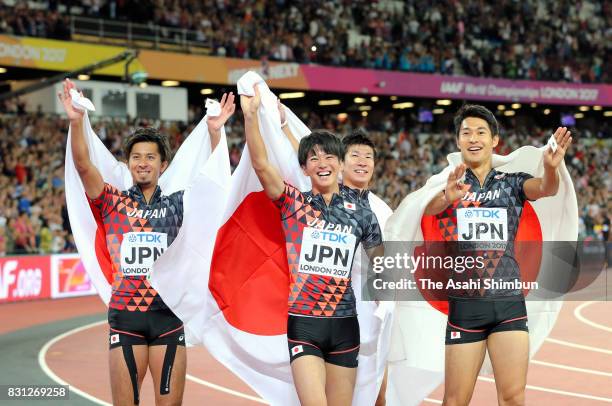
[{"x1": 457, "y1": 207, "x2": 508, "y2": 250}]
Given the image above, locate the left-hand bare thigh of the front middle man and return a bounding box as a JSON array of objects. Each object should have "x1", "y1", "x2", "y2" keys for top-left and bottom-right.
[{"x1": 291, "y1": 355, "x2": 327, "y2": 406}]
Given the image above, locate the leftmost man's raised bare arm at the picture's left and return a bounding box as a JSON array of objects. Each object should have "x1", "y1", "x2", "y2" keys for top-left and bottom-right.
[{"x1": 58, "y1": 79, "x2": 104, "y2": 199}]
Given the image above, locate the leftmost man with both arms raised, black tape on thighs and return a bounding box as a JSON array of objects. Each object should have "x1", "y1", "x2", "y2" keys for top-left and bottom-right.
[{"x1": 59, "y1": 80, "x2": 235, "y2": 405}]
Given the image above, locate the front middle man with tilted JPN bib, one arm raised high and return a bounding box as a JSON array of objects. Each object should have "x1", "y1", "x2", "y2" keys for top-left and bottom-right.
[{"x1": 240, "y1": 87, "x2": 382, "y2": 405}]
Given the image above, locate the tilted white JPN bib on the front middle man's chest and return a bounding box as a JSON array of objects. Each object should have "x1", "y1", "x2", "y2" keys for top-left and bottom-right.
[{"x1": 299, "y1": 227, "x2": 357, "y2": 279}]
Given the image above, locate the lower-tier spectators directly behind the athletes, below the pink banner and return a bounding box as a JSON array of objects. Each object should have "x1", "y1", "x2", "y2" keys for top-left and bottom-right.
[{"x1": 0, "y1": 104, "x2": 612, "y2": 255}]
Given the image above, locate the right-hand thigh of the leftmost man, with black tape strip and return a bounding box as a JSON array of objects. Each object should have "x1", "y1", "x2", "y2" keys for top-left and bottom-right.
[{"x1": 149, "y1": 344, "x2": 187, "y2": 406}]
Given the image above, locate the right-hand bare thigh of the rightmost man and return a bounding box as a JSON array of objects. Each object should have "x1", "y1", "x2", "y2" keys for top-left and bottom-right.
[{"x1": 487, "y1": 331, "x2": 529, "y2": 404}]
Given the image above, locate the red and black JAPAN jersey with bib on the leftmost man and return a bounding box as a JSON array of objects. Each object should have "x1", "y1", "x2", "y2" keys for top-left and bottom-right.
[{"x1": 90, "y1": 183, "x2": 183, "y2": 312}]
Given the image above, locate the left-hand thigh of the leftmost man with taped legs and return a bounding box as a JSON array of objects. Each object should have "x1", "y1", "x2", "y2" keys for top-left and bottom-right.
[{"x1": 108, "y1": 345, "x2": 149, "y2": 406}]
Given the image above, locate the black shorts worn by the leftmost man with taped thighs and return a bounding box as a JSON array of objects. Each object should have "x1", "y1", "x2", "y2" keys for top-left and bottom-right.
[{"x1": 108, "y1": 308, "x2": 185, "y2": 349}]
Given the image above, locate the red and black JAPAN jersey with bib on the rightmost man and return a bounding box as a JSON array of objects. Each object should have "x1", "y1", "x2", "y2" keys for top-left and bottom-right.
[{"x1": 436, "y1": 168, "x2": 532, "y2": 297}]
